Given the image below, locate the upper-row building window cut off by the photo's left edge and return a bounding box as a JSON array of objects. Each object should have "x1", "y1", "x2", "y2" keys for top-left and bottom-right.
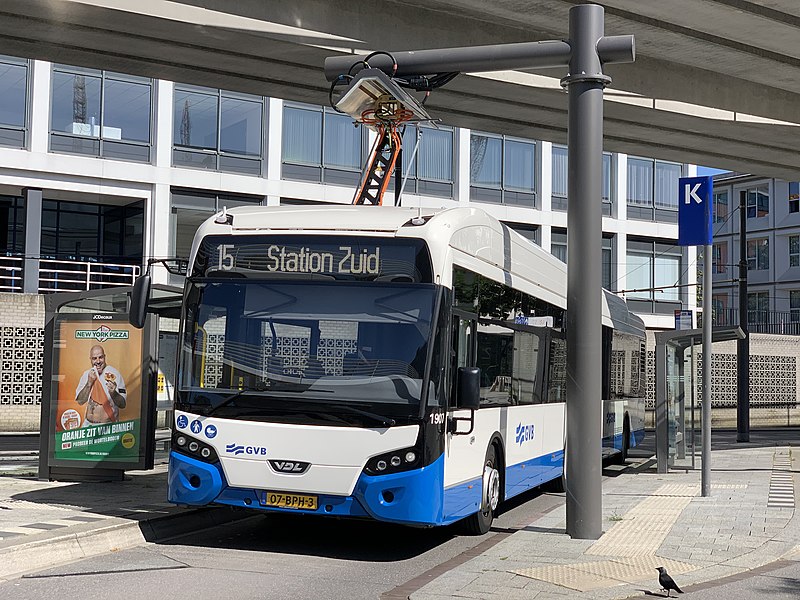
[{"x1": 0, "y1": 56, "x2": 28, "y2": 148}]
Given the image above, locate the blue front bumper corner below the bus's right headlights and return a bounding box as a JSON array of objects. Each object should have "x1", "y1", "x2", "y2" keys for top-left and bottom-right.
[{"x1": 354, "y1": 455, "x2": 444, "y2": 525}]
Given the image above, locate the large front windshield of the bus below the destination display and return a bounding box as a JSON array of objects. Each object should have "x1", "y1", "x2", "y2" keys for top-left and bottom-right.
[{"x1": 179, "y1": 279, "x2": 436, "y2": 416}]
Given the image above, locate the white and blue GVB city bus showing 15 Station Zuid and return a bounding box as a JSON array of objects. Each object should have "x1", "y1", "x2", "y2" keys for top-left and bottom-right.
[{"x1": 169, "y1": 206, "x2": 645, "y2": 533}]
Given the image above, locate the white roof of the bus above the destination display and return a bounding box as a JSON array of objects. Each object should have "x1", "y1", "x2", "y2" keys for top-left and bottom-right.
[{"x1": 189, "y1": 205, "x2": 644, "y2": 335}]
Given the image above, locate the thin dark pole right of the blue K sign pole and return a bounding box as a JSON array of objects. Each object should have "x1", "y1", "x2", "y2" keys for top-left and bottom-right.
[{"x1": 736, "y1": 190, "x2": 750, "y2": 442}]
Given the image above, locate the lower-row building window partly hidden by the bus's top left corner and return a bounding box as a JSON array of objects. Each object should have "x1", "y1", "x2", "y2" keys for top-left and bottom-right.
[{"x1": 170, "y1": 189, "x2": 264, "y2": 260}]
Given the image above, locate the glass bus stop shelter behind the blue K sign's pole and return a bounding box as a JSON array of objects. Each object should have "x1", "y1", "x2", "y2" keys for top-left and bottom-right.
[{"x1": 655, "y1": 327, "x2": 744, "y2": 473}]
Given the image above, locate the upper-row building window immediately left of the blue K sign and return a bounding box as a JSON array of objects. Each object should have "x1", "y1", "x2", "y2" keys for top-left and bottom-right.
[{"x1": 628, "y1": 158, "x2": 682, "y2": 223}]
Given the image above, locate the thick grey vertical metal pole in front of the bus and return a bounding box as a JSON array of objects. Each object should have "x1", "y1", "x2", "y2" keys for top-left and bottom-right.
[{"x1": 562, "y1": 5, "x2": 611, "y2": 539}]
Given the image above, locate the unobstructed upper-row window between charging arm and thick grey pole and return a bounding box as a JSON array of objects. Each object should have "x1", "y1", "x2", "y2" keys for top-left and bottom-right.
[{"x1": 470, "y1": 133, "x2": 536, "y2": 208}]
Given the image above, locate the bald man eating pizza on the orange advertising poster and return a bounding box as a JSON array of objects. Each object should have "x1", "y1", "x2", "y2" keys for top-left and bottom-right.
[{"x1": 75, "y1": 344, "x2": 127, "y2": 427}]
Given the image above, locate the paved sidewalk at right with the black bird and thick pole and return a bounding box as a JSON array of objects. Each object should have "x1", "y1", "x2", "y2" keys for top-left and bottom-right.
[{"x1": 411, "y1": 446, "x2": 800, "y2": 600}]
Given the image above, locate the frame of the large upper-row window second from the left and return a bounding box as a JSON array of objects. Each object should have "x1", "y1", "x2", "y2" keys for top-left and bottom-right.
[{"x1": 48, "y1": 64, "x2": 155, "y2": 164}]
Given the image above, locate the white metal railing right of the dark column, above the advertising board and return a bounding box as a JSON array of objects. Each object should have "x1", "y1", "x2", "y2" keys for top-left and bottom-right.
[{"x1": 39, "y1": 259, "x2": 141, "y2": 293}]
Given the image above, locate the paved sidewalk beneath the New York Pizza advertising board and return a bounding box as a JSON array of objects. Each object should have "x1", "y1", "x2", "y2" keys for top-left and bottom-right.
[{"x1": 0, "y1": 460, "x2": 247, "y2": 581}]
